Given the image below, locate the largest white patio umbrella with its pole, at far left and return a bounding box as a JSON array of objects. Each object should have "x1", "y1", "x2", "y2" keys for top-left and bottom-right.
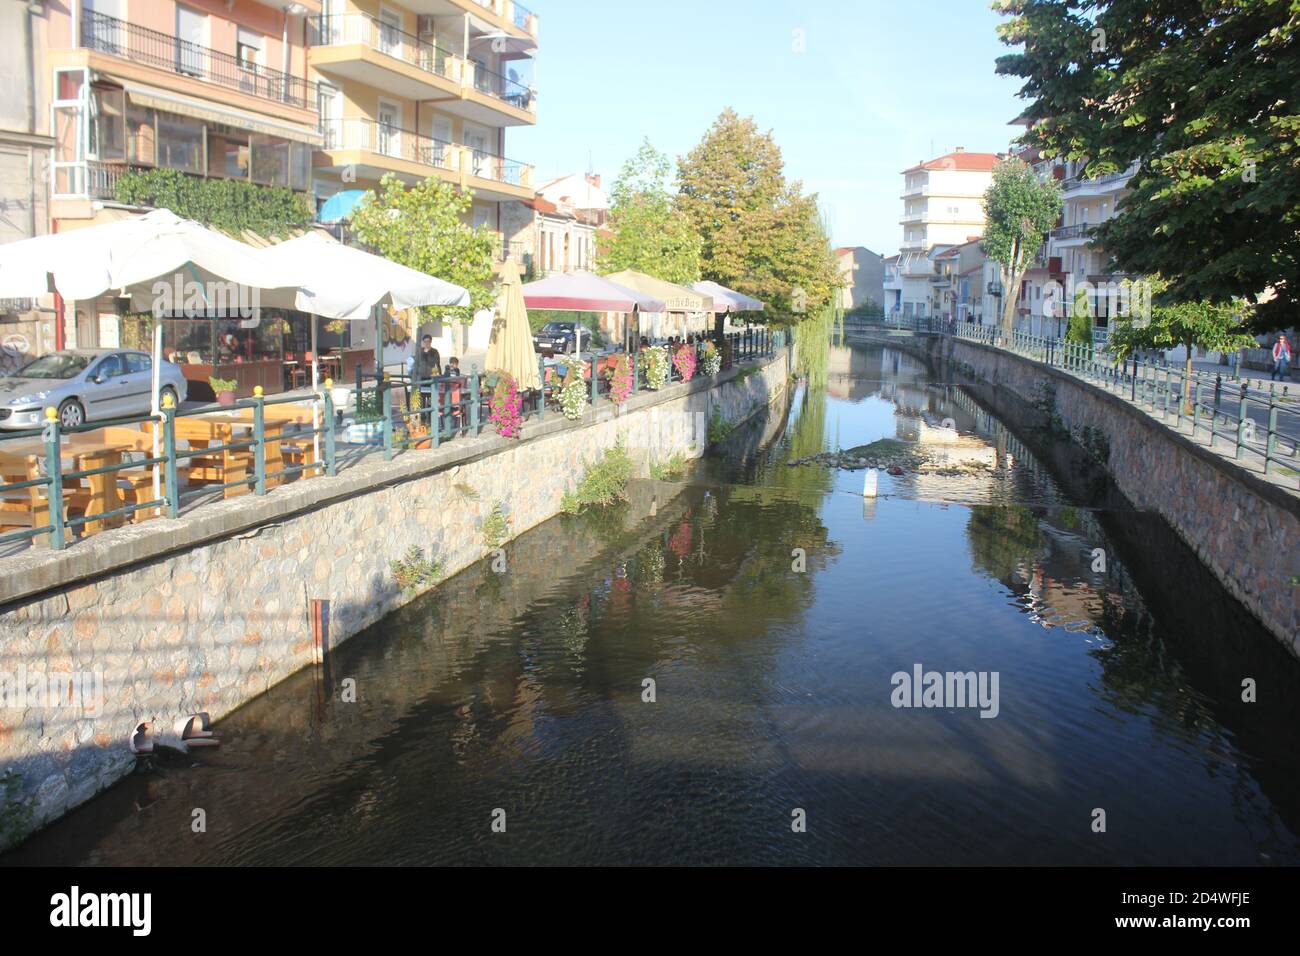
[{"x1": 0, "y1": 209, "x2": 296, "y2": 512}]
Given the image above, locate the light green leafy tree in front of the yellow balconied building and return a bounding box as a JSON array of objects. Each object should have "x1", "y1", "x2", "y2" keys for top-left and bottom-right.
[{"x1": 352, "y1": 173, "x2": 497, "y2": 323}]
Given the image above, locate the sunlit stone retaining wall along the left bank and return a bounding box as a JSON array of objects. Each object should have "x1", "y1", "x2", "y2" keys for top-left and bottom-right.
[{"x1": 0, "y1": 349, "x2": 793, "y2": 848}]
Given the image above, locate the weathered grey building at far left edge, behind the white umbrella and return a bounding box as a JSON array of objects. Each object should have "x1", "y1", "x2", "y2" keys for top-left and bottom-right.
[{"x1": 0, "y1": 3, "x2": 53, "y2": 375}]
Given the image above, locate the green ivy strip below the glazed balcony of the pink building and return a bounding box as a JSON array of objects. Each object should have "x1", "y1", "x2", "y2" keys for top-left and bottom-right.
[{"x1": 114, "y1": 169, "x2": 312, "y2": 238}]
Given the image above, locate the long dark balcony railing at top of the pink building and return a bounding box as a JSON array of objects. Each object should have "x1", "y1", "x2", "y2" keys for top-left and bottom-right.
[{"x1": 81, "y1": 10, "x2": 316, "y2": 109}]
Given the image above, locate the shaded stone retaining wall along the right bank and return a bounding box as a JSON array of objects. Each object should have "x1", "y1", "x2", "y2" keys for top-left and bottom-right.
[{"x1": 946, "y1": 337, "x2": 1300, "y2": 657}]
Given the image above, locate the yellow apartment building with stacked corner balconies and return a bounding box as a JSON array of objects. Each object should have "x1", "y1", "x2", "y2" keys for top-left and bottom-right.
[{"x1": 306, "y1": 0, "x2": 538, "y2": 252}]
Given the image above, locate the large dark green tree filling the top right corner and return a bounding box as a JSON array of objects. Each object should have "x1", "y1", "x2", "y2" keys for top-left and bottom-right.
[{"x1": 995, "y1": 0, "x2": 1300, "y2": 330}]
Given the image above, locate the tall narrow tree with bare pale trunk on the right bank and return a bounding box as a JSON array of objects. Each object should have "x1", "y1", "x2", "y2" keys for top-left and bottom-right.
[{"x1": 983, "y1": 159, "x2": 1061, "y2": 334}]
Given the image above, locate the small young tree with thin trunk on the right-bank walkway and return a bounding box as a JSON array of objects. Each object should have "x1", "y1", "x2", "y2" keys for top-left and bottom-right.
[{"x1": 1110, "y1": 280, "x2": 1255, "y2": 415}]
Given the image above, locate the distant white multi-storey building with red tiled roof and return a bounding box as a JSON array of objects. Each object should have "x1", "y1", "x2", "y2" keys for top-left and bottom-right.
[{"x1": 894, "y1": 147, "x2": 1002, "y2": 316}]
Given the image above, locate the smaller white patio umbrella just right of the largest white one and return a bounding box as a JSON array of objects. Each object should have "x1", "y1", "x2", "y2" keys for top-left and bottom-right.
[{"x1": 257, "y1": 233, "x2": 469, "y2": 458}]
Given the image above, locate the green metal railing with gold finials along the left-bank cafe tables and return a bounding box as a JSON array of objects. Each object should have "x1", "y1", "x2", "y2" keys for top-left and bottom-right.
[{"x1": 0, "y1": 328, "x2": 784, "y2": 550}]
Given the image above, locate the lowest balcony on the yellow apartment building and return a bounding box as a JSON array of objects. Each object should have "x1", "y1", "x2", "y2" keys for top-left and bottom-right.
[{"x1": 317, "y1": 118, "x2": 533, "y2": 202}]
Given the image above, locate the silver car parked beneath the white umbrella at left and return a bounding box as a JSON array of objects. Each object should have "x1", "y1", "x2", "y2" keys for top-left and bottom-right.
[{"x1": 0, "y1": 349, "x2": 186, "y2": 429}]
